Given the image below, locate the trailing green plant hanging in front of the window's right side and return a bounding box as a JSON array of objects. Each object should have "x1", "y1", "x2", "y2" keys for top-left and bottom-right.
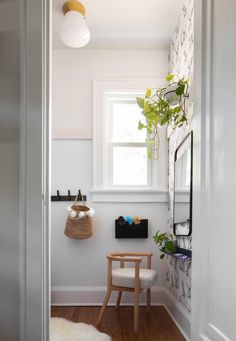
[{"x1": 136, "y1": 74, "x2": 189, "y2": 159}]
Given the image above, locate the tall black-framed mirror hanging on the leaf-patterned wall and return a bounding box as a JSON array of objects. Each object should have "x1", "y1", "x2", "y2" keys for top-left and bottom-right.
[{"x1": 173, "y1": 132, "x2": 193, "y2": 236}]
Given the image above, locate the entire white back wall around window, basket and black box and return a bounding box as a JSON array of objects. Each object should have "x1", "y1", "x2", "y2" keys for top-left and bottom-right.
[{"x1": 52, "y1": 50, "x2": 168, "y2": 303}]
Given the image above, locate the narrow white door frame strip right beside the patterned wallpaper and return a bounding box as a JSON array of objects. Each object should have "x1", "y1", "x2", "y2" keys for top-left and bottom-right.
[{"x1": 191, "y1": 0, "x2": 213, "y2": 341}]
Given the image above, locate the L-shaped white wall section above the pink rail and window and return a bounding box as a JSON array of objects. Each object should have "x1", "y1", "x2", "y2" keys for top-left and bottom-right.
[{"x1": 52, "y1": 49, "x2": 168, "y2": 129}]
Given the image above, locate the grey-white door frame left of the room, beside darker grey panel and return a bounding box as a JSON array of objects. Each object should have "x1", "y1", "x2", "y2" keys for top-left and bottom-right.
[{"x1": 19, "y1": 0, "x2": 51, "y2": 341}]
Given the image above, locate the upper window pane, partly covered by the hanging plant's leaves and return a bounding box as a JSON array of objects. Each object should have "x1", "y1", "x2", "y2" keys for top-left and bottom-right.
[{"x1": 111, "y1": 102, "x2": 146, "y2": 142}]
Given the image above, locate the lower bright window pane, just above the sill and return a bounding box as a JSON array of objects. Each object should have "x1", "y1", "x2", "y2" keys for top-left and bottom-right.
[{"x1": 113, "y1": 147, "x2": 147, "y2": 186}]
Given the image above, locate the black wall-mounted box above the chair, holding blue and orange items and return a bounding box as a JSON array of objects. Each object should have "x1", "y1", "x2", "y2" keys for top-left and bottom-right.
[{"x1": 115, "y1": 219, "x2": 148, "y2": 239}]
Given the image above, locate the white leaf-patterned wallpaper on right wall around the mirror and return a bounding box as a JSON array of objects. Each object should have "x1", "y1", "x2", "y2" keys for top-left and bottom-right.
[{"x1": 166, "y1": 0, "x2": 194, "y2": 313}]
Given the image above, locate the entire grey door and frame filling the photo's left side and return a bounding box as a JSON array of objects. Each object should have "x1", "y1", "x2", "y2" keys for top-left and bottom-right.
[{"x1": 0, "y1": 0, "x2": 50, "y2": 341}]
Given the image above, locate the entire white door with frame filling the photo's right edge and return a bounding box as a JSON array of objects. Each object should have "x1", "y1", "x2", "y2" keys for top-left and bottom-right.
[{"x1": 192, "y1": 0, "x2": 236, "y2": 341}]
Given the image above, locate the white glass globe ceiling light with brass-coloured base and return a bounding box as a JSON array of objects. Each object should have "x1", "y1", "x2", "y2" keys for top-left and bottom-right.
[{"x1": 60, "y1": 0, "x2": 90, "y2": 48}]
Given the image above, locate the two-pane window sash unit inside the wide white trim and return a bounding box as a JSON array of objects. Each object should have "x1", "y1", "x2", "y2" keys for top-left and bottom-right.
[{"x1": 104, "y1": 93, "x2": 151, "y2": 187}]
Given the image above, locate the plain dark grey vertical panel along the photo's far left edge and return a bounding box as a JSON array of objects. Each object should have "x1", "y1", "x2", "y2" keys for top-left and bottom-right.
[{"x1": 0, "y1": 0, "x2": 20, "y2": 341}]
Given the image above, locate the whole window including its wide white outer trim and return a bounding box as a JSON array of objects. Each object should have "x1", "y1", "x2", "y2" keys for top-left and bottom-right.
[{"x1": 91, "y1": 80, "x2": 168, "y2": 202}]
